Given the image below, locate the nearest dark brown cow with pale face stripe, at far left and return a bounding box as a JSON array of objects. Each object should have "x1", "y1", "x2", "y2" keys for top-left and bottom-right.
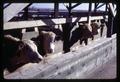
[{"x1": 3, "y1": 35, "x2": 43, "y2": 72}]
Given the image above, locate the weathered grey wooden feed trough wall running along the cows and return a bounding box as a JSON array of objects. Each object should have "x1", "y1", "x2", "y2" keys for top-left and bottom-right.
[{"x1": 4, "y1": 34, "x2": 116, "y2": 79}]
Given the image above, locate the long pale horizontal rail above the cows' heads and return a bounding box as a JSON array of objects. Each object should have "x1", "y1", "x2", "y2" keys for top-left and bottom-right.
[{"x1": 3, "y1": 16, "x2": 107, "y2": 30}]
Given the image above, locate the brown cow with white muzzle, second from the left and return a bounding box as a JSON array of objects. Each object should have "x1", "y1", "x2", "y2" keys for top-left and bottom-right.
[{"x1": 31, "y1": 30, "x2": 56, "y2": 56}]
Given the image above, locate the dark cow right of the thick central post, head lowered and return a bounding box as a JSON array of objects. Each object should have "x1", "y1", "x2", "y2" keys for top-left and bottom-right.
[{"x1": 69, "y1": 23, "x2": 94, "y2": 47}]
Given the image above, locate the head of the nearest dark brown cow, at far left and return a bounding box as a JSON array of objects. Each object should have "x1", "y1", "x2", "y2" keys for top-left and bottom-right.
[{"x1": 10, "y1": 40, "x2": 43, "y2": 66}]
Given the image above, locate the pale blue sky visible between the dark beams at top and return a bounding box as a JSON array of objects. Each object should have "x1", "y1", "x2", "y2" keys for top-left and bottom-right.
[{"x1": 30, "y1": 3, "x2": 105, "y2": 10}]
